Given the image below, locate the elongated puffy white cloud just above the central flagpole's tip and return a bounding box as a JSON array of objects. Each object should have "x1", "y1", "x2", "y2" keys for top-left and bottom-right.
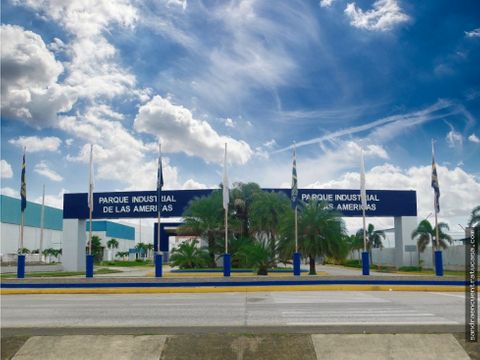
[{"x1": 134, "y1": 95, "x2": 252, "y2": 164}]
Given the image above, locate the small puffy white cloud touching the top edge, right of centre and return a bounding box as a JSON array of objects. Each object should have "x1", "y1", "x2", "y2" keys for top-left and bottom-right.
[{"x1": 345, "y1": 0, "x2": 410, "y2": 31}]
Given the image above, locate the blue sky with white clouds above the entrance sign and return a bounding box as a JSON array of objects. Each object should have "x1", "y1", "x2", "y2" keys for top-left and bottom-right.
[{"x1": 1, "y1": 0, "x2": 480, "y2": 233}]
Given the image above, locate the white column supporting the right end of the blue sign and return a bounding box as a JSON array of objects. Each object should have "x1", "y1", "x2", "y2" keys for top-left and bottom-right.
[{"x1": 394, "y1": 216, "x2": 418, "y2": 268}]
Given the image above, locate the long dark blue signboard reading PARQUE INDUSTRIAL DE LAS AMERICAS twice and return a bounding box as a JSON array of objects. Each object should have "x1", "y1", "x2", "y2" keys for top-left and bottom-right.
[{"x1": 63, "y1": 189, "x2": 417, "y2": 219}]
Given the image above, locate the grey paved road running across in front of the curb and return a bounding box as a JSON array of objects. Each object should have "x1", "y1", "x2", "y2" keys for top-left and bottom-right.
[{"x1": 1, "y1": 291, "x2": 464, "y2": 328}]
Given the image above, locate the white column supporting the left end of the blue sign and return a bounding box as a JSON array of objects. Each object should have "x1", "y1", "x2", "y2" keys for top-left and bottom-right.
[{"x1": 62, "y1": 219, "x2": 87, "y2": 271}]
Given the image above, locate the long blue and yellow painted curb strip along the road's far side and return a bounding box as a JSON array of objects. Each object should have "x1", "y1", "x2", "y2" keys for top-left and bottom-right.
[{"x1": 0, "y1": 276, "x2": 472, "y2": 295}]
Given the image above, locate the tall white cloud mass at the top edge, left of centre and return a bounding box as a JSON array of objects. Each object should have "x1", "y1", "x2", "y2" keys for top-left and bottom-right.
[{"x1": 15, "y1": 0, "x2": 139, "y2": 100}]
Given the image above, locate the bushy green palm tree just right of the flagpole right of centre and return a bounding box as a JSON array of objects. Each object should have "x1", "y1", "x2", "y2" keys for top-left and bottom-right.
[{"x1": 282, "y1": 201, "x2": 346, "y2": 275}]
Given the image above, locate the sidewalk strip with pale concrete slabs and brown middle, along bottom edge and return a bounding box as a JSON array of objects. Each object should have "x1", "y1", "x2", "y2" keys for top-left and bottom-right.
[{"x1": 6, "y1": 334, "x2": 470, "y2": 360}]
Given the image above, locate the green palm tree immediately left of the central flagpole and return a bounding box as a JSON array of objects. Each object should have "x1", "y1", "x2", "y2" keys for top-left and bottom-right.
[{"x1": 179, "y1": 190, "x2": 225, "y2": 268}]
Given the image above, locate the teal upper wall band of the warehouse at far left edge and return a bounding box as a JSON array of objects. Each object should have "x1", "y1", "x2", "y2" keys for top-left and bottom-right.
[{"x1": 0, "y1": 195, "x2": 63, "y2": 230}]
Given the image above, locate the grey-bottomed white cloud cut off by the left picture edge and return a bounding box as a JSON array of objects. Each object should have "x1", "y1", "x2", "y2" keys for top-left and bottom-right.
[{"x1": 1, "y1": 25, "x2": 76, "y2": 128}]
